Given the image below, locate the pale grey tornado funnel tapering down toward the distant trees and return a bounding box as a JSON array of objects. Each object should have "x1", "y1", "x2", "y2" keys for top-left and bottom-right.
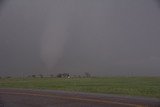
[{"x1": 41, "y1": 1, "x2": 72, "y2": 70}]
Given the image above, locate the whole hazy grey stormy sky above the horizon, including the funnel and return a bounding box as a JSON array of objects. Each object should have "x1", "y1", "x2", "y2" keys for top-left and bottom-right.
[{"x1": 0, "y1": 0, "x2": 160, "y2": 76}]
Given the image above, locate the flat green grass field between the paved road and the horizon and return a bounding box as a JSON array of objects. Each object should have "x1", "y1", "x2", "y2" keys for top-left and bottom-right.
[{"x1": 0, "y1": 77, "x2": 160, "y2": 98}]
